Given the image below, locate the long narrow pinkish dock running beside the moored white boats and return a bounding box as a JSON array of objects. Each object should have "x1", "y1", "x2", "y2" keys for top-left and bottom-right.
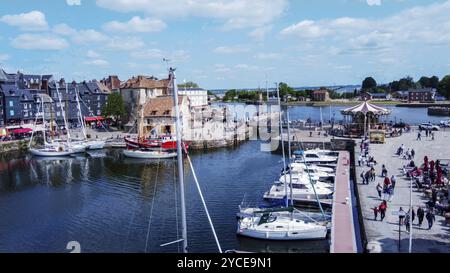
[{"x1": 330, "y1": 152, "x2": 358, "y2": 253}]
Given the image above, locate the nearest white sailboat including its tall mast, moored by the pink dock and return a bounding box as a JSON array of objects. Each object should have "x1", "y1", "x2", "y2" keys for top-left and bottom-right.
[{"x1": 237, "y1": 82, "x2": 327, "y2": 241}]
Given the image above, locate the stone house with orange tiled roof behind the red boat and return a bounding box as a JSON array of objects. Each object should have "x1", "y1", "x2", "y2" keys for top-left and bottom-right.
[{"x1": 144, "y1": 96, "x2": 191, "y2": 135}]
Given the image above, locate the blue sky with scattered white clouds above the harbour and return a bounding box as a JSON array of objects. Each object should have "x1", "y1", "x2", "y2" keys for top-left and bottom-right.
[{"x1": 0, "y1": 0, "x2": 450, "y2": 89}]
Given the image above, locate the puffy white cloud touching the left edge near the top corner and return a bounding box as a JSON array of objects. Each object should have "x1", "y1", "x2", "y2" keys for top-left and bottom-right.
[{"x1": 0, "y1": 10, "x2": 48, "y2": 31}]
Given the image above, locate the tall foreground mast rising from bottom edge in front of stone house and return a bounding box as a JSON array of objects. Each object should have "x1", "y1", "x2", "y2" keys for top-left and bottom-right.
[{"x1": 169, "y1": 68, "x2": 188, "y2": 253}]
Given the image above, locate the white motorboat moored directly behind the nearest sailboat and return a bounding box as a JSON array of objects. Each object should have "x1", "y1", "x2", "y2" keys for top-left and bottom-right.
[{"x1": 264, "y1": 184, "x2": 333, "y2": 201}]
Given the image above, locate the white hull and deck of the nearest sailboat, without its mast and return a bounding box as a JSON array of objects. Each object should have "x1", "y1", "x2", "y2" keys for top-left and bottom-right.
[{"x1": 237, "y1": 213, "x2": 327, "y2": 241}]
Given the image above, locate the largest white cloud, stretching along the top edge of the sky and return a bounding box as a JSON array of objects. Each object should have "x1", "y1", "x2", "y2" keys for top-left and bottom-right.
[{"x1": 97, "y1": 0, "x2": 288, "y2": 29}]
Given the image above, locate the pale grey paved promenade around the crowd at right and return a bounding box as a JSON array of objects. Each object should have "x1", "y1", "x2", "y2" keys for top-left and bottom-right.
[{"x1": 355, "y1": 129, "x2": 450, "y2": 253}]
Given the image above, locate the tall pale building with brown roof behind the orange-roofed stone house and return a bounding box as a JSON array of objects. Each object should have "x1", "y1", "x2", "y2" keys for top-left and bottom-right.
[{"x1": 120, "y1": 76, "x2": 171, "y2": 126}]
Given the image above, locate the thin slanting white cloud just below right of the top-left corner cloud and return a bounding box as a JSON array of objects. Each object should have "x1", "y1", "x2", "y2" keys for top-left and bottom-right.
[{"x1": 53, "y1": 24, "x2": 109, "y2": 44}]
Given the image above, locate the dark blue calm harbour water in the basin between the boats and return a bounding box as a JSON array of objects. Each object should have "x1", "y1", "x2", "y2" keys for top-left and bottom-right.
[{"x1": 0, "y1": 142, "x2": 328, "y2": 252}]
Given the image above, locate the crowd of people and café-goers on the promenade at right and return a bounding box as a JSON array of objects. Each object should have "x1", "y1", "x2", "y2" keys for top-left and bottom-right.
[{"x1": 357, "y1": 135, "x2": 450, "y2": 232}]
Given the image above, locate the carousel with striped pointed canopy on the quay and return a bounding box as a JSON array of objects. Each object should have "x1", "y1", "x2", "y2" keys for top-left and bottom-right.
[{"x1": 341, "y1": 101, "x2": 392, "y2": 143}]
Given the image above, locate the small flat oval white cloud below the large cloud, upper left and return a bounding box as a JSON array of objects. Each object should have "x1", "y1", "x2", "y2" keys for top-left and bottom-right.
[{"x1": 103, "y1": 16, "x2": 167, "y2": 33}]
